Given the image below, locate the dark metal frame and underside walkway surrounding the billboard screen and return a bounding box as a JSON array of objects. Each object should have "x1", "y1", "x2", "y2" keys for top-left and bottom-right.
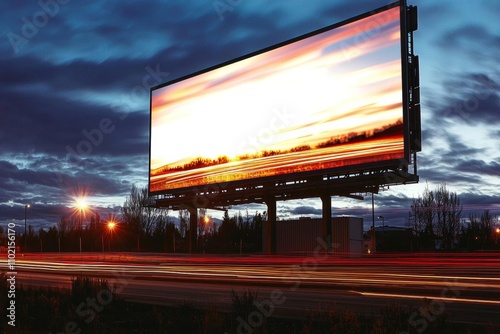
[{"x1": 148, "y1": 0, "x2": 419, "y2": 209}]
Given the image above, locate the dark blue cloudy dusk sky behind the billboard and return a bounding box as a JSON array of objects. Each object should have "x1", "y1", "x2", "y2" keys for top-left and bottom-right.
[{"x1": 0, "y1": 0, "x2": 500, "y2": 231}]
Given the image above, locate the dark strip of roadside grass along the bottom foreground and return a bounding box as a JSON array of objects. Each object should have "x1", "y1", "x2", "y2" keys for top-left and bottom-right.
[{"x1": 0, "y1": 274, "x2": 500, "y2": 334}]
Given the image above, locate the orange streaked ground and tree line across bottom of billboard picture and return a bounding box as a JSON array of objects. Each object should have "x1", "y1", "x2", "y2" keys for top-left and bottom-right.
[{"x1": 150, "y1": 120, "x2": 404, "y2": 191}]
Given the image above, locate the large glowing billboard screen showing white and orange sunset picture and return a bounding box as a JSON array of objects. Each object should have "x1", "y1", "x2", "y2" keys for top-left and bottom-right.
[{"x1": 149, "y1": 1, "x2": 409, "y2": 194}]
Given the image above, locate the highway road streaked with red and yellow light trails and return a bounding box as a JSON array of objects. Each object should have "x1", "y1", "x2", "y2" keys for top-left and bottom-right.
[{"x1": 5, "y1": 253, "x2": 500, "y2": 328}]
